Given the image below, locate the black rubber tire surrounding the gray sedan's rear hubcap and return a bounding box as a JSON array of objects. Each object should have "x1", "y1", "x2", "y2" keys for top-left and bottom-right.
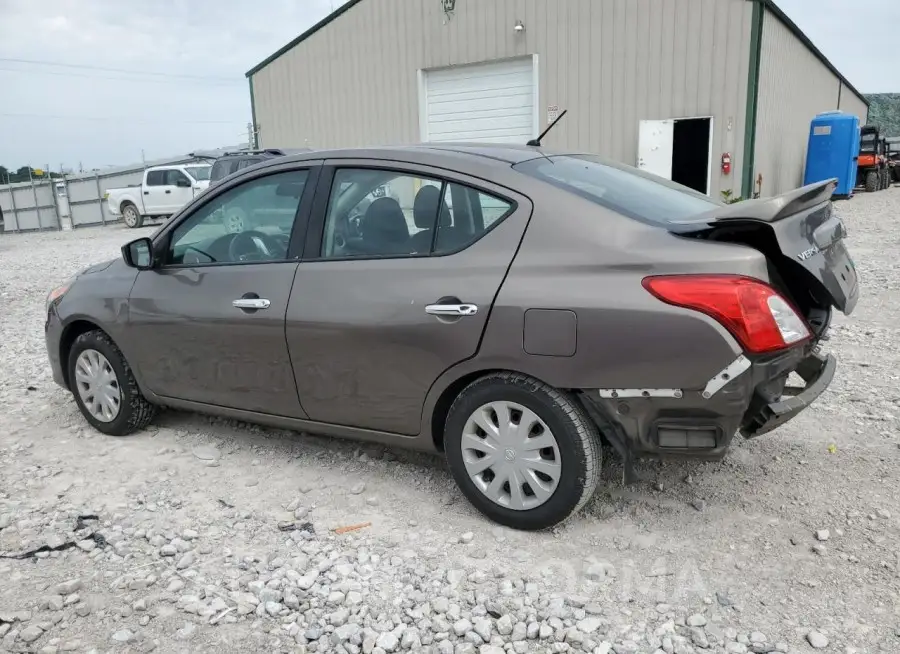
[{"x1": 444, "y1": 372, "x2": 602, "y2": 531}]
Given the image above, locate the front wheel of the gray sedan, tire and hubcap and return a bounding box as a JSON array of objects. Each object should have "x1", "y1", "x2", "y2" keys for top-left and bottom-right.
[{"x1": 68, "y1": 330, "x2": 156, "y2": 436}]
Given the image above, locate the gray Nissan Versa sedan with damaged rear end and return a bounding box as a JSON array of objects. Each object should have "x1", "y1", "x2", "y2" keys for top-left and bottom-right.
[{"x1": 46, "y1": 144, "x2": 858, "y2": 529}]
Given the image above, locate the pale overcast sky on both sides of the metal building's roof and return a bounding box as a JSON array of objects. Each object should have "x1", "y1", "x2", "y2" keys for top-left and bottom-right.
[{"x1": 0, "y1": 0, "x2": 900, "y2": 170}]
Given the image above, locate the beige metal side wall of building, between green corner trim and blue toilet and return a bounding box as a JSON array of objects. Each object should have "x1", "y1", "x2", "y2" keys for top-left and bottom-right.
[{"x1": 754, "y1": 10, "x2": 852, "y2": 197}]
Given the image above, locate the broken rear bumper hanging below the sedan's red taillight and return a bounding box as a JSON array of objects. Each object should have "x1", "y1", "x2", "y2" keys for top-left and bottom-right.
[{"x1": 579, "y1": 347, "x2": 837, "y2": 462}]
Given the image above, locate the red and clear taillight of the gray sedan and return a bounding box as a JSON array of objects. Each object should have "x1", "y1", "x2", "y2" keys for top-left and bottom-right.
[{"x1": 643, "y1": 275, "x2": 812, "y2": 354}]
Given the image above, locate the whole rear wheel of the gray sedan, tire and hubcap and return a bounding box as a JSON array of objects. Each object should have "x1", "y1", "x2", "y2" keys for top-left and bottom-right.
[{"x1": 444, "y1": 372, "x2": 601, "y2": 530}]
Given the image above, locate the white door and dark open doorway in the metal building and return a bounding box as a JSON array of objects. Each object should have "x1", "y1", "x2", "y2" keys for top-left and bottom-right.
[{"x1": 638, "y1": 116, "x2": 713, "y2": 195}]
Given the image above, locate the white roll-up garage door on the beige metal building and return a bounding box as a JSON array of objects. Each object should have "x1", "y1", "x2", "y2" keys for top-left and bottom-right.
[{"x1": 421, "y1": 57, "x2": 537, "y2": 144}]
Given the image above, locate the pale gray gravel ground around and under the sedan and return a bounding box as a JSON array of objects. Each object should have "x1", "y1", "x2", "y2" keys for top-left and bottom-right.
[{"x1": 0, "y1": 188, "x2": 900, "y2": 654}]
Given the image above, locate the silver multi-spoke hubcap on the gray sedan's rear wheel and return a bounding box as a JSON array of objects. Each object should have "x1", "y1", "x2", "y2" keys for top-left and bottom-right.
[{"x1": 461, "y1": 402, "x2": 562, "y2": 511}]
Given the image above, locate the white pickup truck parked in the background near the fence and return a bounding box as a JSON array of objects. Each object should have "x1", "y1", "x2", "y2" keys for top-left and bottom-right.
[{"x1": 103, "y1": 163, "x2": 210, "y2": 228}]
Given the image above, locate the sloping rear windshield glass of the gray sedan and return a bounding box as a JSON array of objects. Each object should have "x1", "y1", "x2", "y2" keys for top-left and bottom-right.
[{"x1": 513, "y1": 155, "x2": 722, "y2": 225}]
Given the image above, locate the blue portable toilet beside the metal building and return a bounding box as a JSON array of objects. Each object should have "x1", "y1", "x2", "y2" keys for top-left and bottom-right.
[{"x1": 803, "y1": 111, "x2": 859, "y2": 198}]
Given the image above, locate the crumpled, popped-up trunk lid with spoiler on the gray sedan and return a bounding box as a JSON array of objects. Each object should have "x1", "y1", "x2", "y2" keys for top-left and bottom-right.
[{"x1": 670, "y1": 180, "x2": 859, "y2": 314}]
